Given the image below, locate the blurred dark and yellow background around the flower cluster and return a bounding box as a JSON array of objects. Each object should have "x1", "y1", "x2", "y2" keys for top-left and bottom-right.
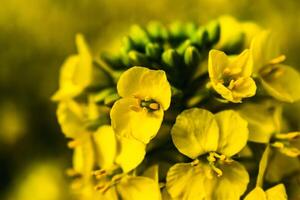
[{"x1": 0, "y1": 0, "x2": 300, "y2": 200}]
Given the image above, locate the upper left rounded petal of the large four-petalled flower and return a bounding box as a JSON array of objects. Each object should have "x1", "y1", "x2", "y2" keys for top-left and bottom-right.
[{"x1": 171, "y1": 108, "x2": 219, "y2": 159}]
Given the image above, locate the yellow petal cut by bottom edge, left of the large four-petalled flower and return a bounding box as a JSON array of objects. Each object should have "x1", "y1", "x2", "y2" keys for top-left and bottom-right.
[{"x1": 116, "y1": 176, "x2": 161, "y2": 200}]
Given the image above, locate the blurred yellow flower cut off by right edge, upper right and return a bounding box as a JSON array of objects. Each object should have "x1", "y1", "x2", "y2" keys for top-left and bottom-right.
[{"x1": 250, "y1": 31, "x2": 300, "y2": 102}]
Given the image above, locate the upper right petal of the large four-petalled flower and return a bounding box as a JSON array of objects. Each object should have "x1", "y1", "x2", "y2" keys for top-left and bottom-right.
[{"x1": 215, "y1": 110, "x2": 249, "y2": 157}]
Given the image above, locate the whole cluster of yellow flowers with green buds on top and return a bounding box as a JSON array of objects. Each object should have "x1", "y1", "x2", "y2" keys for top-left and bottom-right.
[{"x1": 52, "y1": 16, "x2": 300, "y2": 200}]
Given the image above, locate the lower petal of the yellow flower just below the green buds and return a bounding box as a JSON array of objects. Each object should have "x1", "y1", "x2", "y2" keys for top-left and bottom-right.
[{"x1": 110, "y1": 97, "x2": 164, "y2": 144}]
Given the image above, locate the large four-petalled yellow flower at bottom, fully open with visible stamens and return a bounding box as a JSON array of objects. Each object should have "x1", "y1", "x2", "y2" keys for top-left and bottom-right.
[{"x1": 167, "y1": 108, "x2": 249, "y2": 200}]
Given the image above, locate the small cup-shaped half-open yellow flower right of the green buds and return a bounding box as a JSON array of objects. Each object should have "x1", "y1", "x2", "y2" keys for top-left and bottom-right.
[{"x1": 208, "y1": 50, "x2": 256, "y2": 103}]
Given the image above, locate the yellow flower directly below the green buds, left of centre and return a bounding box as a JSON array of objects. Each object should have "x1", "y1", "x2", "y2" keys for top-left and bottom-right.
[{"x1": 110, "y1": 67, "x2": 171, "y2": 144}]
